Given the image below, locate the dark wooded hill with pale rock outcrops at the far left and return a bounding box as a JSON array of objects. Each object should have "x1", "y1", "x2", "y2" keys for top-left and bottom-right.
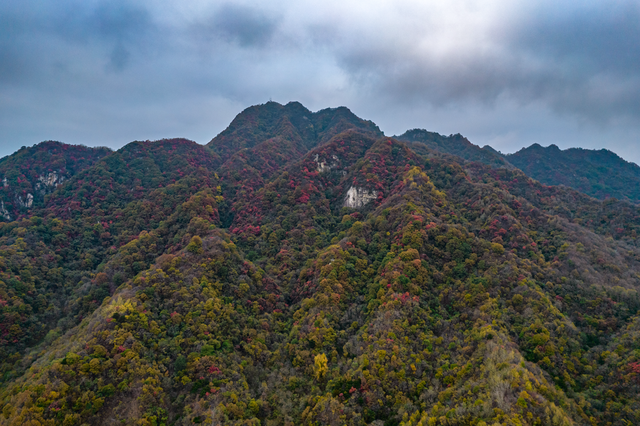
[{"x1": 0, "y1": 141, "x2": 111, "y2": 221}]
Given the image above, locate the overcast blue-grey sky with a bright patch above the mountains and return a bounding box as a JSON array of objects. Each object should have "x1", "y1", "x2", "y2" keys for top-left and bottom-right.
[{"x1": 0, "y1": 0, "x2": 640, "y2": 163}]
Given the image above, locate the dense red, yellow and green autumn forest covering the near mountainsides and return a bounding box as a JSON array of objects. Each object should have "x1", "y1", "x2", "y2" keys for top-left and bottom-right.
[{"x1": 0, "y1": 102, "x2": 640, "y2": 426}]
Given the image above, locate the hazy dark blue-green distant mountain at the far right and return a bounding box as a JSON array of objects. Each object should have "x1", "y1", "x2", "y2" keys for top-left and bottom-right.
[{"x1": 505, "y1": 144, "x2": 640, "y2": 203}]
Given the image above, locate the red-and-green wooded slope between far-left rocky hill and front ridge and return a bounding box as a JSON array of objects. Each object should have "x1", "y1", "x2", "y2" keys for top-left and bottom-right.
[{"x1": 0, "y1": 139, "x2": 221, "y2": 380}]
